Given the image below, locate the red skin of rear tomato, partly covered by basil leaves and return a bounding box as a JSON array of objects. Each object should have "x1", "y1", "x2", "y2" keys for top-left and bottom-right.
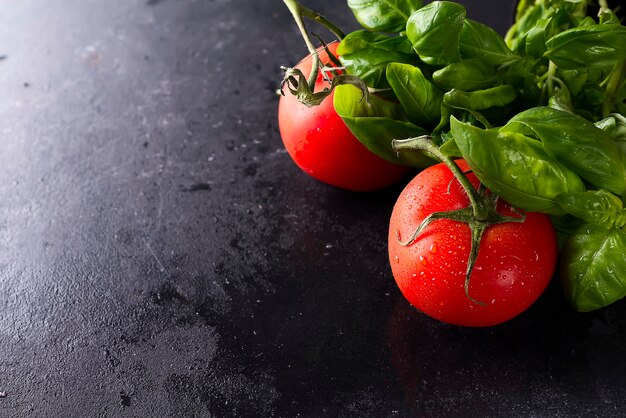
[{"x1": 278, "y1": 42, "x2": 410, "y2": 191}]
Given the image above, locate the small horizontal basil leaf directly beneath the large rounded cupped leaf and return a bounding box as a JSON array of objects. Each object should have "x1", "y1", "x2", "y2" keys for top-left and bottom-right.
[{"x1": 433, "y1": 59, "x2": 498, "y2": 91}]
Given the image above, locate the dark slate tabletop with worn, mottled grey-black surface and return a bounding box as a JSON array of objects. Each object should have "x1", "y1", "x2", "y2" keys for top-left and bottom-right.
[{"x1": 0, "y1": 0, "x2": 626, "y2": 417}]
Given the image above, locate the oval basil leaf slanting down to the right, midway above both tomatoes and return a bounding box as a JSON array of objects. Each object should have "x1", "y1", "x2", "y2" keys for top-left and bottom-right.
[{"x1": 387, "y1": 63, "x2": 443, "y2": 126}]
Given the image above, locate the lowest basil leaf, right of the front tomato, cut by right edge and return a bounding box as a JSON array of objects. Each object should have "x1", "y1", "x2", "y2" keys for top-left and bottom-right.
[{"x1": 559, "y1": 224, "x2": 626, "y2": 312}]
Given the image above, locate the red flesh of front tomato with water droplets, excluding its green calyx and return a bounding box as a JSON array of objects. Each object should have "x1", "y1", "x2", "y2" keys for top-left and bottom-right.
[{"x1": 389, "y1": 160, "x2": 557, "y2": 326}]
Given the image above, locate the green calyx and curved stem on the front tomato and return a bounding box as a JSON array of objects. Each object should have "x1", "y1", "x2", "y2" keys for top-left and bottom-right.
[{"x1": 392, "y1": 135, "x2": 526, "y2": 306}]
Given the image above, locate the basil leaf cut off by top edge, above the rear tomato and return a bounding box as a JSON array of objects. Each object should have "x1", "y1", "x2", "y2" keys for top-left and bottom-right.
[{"x1": 348, "y1": 0, "x2": 422, "y2": 32}]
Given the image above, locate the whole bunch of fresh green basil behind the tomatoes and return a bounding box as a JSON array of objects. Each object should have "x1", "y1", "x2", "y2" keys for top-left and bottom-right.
[{"x1": 334, "y1": 0, "x2": 626, "y2": 311}]
